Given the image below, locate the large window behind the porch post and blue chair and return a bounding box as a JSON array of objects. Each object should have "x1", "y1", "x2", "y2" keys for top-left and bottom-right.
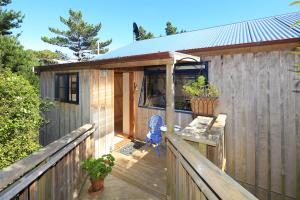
[{"x1": 139, "y1": 62, "x2": 208, "y2": 111}]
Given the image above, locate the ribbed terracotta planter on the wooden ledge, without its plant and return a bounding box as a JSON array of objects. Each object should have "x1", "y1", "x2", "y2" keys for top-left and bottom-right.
[{"x1": 191, "y1": 97, "x2": 218, "y2": 116}]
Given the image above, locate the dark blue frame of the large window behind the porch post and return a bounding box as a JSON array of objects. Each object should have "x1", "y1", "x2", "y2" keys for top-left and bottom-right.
[{"x1": 138, "y1": 61, "x2": 209, "y2": 114}]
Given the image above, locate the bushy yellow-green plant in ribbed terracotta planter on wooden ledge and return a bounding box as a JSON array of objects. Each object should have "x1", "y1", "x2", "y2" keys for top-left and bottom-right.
[{"x1": 183, "y1": 76, "x2": 219, "y2": 116}]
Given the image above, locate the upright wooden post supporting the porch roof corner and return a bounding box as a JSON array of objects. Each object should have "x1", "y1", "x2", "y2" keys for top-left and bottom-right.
[{"x1": 166, "y1": 62, "x2": 175, "y2": 134}]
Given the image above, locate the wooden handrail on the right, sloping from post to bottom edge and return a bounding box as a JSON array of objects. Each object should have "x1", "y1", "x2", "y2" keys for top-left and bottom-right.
[{"x1": 167, "y1": 134, "x2": 257, "y2": 200}]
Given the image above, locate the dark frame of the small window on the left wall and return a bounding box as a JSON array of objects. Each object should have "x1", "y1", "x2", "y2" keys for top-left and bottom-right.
[{"x1": 54, "y1": 72, "x2": 79, "y2": 104}]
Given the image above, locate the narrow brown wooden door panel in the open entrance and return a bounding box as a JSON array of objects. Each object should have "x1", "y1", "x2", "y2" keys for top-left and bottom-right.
[{"x1": 114, "y1": 72, "x2": 123, "y2": 133}]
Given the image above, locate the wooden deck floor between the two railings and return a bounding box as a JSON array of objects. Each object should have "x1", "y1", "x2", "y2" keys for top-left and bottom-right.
[{"x1": 79, "y1": 143, "x2": 167, "y2": 200}]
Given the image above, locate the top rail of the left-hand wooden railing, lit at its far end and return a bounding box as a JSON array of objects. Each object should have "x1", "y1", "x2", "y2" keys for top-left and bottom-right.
[{"x1": 0, "y1": 124, "x2": 95, "y2": 192}]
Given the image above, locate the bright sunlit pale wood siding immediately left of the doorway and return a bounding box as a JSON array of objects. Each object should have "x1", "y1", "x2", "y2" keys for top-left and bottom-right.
[{"x1": 89, "y1": 70, "x2": 114, "y2": 157}]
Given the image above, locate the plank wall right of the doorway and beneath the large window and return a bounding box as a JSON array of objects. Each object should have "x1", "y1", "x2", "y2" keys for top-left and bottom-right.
[{"x1": 134, "y1": 71, "x2": 192, "y2": 141}]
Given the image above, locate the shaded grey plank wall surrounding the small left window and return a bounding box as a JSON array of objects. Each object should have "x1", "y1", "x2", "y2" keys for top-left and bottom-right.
[{"x1": 40, "y1": 70, "x2": 90, "y2": 146}]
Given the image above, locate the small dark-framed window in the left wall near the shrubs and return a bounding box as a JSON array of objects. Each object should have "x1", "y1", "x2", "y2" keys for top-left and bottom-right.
[{"x1": 55, "y1": 72, "x2": 79, "y2": 104}]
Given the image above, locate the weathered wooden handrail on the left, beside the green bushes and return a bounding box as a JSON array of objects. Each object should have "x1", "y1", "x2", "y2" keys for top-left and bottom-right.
[{"x1": 0, "y1": 124, "x2": 95, "y2": 192}]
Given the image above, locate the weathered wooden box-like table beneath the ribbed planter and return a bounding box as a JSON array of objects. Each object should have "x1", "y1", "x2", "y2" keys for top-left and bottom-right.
[{"x1": 176, "y1": 114, "x2": 226, "y2": 169}]
